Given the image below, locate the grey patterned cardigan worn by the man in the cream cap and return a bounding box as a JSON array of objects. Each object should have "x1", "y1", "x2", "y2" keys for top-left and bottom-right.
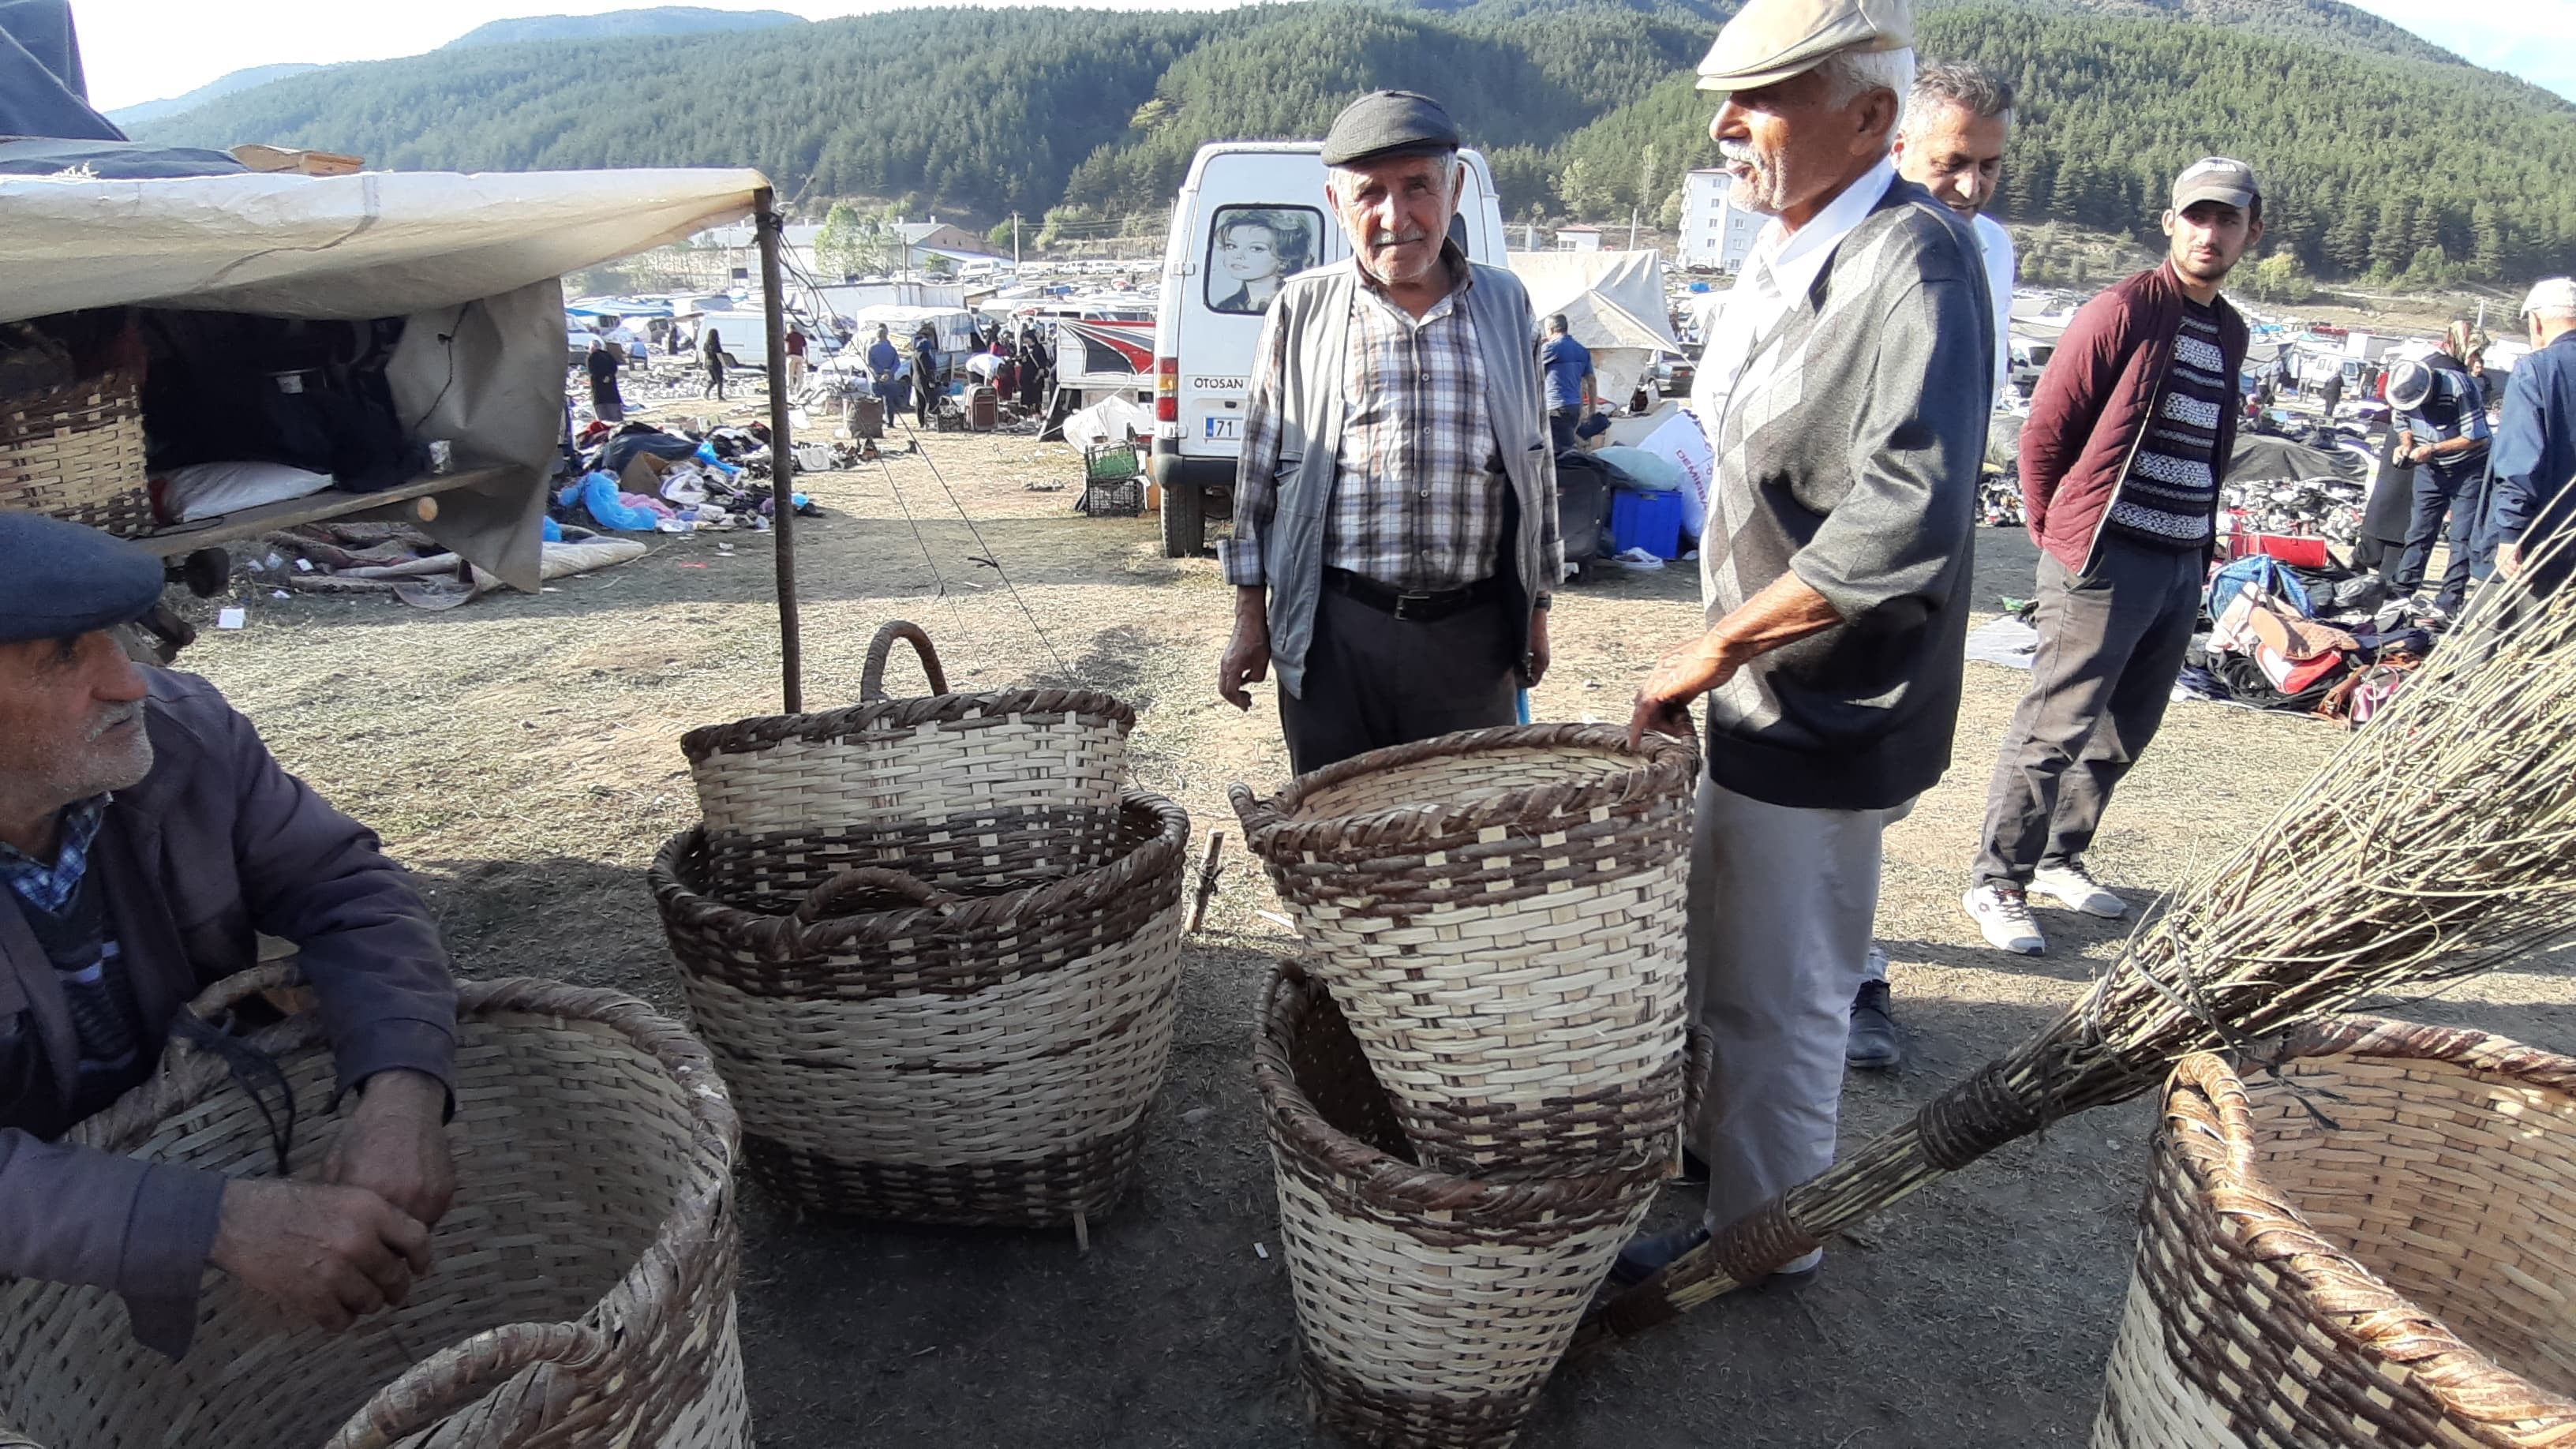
[{"x1": 1700, "y1": 181, "x2": 1994, "y2": 810}]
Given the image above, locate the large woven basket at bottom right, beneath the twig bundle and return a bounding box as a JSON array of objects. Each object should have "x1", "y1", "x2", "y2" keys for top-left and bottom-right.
[{"x1": 2091, "y1": 1018, "x2": 2576, "y2": 1449}]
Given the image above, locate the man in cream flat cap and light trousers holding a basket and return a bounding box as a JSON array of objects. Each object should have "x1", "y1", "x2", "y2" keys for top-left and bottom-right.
[{"x1": 1620, "y1": 0, "x2": 1997, "y2": 1279}]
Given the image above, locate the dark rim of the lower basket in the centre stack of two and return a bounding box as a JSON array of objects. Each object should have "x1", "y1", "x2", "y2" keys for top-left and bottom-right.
[{"x1": 1252, "y1": 962, "x2": 1672, "y2": 1222}]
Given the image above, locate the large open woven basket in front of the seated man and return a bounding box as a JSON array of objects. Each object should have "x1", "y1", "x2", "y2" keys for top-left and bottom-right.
[{"x1": 0, "y1": 967, "x2": 752, "y2": 1449}]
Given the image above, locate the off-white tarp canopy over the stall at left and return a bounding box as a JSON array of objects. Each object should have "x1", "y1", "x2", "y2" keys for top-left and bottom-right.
[{"x1": 0, "y1": 170, "x2": 768, "y2": 322}]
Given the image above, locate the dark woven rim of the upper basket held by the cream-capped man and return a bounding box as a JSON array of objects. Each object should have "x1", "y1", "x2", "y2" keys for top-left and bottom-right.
[{"x1": 1226, "y1": 724, "x2": 1700, "y2": 859}]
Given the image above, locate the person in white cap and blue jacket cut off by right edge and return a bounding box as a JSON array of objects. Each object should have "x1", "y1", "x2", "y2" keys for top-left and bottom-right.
[{"x1": 2494, "y1": 276, "x2": 2576, "y2": 593}]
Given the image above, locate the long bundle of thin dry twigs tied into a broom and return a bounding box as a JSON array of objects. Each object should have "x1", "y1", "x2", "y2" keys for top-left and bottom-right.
[{"x1": 1574, "y1": 541, "x2": 2576, "y2": 1354}]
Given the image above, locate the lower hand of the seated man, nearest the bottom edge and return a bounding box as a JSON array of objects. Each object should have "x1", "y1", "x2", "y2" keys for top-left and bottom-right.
[{"x1": 208, "y1": 1178, "x2": 430, "y2": 1333}]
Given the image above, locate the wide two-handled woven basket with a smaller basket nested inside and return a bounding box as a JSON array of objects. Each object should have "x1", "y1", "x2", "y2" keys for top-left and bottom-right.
[{"x1": 652, "y1": 792, "x2": 1190, "y2": 1233}]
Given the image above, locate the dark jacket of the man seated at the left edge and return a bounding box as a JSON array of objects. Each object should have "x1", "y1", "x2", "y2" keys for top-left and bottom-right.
[{"x1": 0, "y1": 670, "x2": 456, "y2": 1359}]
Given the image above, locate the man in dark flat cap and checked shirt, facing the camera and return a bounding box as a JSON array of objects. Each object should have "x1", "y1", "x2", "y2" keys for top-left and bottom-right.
[{"x1": 1216, "y1": 90, "x2": 1563, "y2": 773}]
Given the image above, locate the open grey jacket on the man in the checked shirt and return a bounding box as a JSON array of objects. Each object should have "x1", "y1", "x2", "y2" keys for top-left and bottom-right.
[{"x1": 1257, "y1": 258, "x2": 1563, "y2": 696}]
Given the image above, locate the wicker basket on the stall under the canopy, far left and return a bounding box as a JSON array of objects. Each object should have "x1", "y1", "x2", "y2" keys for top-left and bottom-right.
[{"x1": 0, "y1": 369, "x2": 152, "y2": 534}]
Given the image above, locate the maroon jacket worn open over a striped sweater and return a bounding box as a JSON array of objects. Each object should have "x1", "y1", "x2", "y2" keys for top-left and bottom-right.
[{"x1": 2022, "y1": 263, "x2": 2246, "y2": 575}]
